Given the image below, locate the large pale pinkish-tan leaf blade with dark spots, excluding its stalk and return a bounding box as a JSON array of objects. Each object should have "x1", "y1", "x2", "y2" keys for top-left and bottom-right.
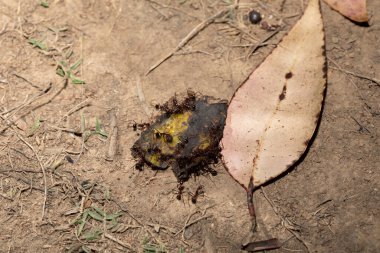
[{"x1": 221, "y1": 0, "x2": 326, "y2": 189}]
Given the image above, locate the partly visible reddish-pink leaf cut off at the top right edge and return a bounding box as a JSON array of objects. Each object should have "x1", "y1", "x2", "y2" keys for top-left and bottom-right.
[{"x1": 325, "y1": 0, "x2": 368, "y2": 22}]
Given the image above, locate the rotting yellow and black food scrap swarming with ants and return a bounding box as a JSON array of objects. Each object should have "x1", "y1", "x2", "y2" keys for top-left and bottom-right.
[{"x1": 131, "y1": 92, "x2": 227, "y2": 182}]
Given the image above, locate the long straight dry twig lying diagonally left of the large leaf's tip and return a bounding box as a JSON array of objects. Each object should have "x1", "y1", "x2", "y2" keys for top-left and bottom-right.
[{"x1": 145, "y1": 5, "x2": 236, "y2": 75}]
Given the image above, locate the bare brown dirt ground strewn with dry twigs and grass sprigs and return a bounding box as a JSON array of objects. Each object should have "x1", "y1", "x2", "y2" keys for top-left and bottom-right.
[{"x1": 0, "y1": 0, "x2": 380, "y2": 253}]
